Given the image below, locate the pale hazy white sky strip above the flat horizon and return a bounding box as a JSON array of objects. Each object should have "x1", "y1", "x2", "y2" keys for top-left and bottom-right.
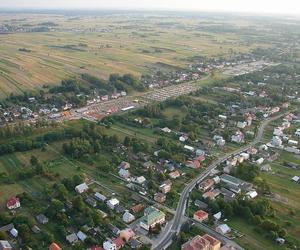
[{"x1": 0, "y1": 0, "x2": 300, "y2": 14}]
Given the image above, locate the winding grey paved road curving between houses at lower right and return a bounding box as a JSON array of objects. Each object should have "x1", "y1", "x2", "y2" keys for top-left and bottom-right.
[{"x1": 152, "y1": 111, "x2": 291, "y2": 250}]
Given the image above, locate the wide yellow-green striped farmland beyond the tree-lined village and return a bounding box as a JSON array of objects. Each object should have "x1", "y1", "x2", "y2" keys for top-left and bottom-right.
[{"x1": 0, "y1": 14, "x2": 274, "y2": 97}]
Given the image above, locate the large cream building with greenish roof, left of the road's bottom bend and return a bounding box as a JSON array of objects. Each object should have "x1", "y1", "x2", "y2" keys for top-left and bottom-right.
[{"x1": 140, "y1": 207, "x2": 166, "y2": 231}]
